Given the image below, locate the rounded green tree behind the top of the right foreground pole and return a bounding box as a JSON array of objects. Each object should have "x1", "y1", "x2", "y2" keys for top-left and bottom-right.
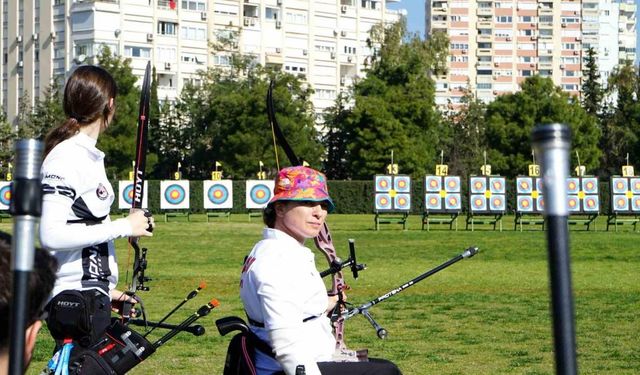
[{"x1": 486, "y1": 76, "x2": 601, "y2": 177}]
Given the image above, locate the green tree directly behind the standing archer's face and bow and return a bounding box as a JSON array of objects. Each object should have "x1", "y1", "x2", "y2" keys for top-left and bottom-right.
[{"x1": 97, "y1": 46, "x2": 157, "y2": 179}]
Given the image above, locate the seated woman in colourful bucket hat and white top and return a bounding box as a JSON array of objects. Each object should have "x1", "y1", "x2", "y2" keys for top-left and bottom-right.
[{"x1": 240, "y1": 166, "x2": 400, "y2": 375}]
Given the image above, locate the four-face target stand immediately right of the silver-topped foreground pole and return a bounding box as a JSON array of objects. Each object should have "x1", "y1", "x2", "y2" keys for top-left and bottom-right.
[{"x1": 567, "y1": 176, "x2": 600, "y2": 231}]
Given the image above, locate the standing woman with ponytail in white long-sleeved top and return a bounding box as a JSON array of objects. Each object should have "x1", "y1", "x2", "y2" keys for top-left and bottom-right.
[{"x1": 40, "y1": 65, "x2": 154, "y2": 341}]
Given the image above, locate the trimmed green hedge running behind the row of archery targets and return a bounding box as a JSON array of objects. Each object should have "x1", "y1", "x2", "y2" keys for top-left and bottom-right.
[{"x1": 111, "y1": 179, "x2": 611, "y2": 214}]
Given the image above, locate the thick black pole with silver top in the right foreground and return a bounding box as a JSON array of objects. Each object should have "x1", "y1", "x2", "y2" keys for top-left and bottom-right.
[{"x1": 532, "y1": 124, "x2": 578, "y2": 375}]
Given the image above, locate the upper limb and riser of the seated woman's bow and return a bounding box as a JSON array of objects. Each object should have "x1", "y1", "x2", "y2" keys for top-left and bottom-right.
[{"x1": 267, "y1": 80, "x2": 348, "y2": 353}]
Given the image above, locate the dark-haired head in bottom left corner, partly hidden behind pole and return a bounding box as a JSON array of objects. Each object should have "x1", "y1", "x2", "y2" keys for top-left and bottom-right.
[{"x1": 0, "y1": 232, "x2": 57, "y2": 375}]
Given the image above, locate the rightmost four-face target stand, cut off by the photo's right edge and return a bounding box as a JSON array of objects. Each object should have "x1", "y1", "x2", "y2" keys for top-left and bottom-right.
[{"x1": 607, "y1": 176, "x2": 640, "y2": 232}]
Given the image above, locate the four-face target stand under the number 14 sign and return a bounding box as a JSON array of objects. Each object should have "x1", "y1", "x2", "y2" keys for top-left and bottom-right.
[{"x1": 422, "y1": 175, "x2": 462, "y2": 231}]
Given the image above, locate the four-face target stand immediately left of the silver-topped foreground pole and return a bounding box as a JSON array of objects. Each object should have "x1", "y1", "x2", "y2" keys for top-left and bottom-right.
[{"x1": 513, "y1": 176, "x2": 545, "y2": 232}]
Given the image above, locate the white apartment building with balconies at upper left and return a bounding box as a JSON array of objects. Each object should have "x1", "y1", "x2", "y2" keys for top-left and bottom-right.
[{"x1": 0, "y1": 0, "x2": 402, "y2": 123}]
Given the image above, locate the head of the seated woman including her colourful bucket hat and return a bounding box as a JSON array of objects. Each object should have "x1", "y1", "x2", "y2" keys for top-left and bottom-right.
[{"x1": 263, "y1": 166, "x2": 334, "y2": 243}]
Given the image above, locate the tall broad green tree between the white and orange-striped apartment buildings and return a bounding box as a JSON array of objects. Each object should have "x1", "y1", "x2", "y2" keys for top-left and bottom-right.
[{"x1": 343, "y1": 22, "x2": 447, "y2": 179}]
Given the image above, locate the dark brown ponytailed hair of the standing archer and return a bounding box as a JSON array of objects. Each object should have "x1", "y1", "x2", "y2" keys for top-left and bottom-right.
[{"x1": 44, "y1": 65, "x2": 117, "y2": 157}]
